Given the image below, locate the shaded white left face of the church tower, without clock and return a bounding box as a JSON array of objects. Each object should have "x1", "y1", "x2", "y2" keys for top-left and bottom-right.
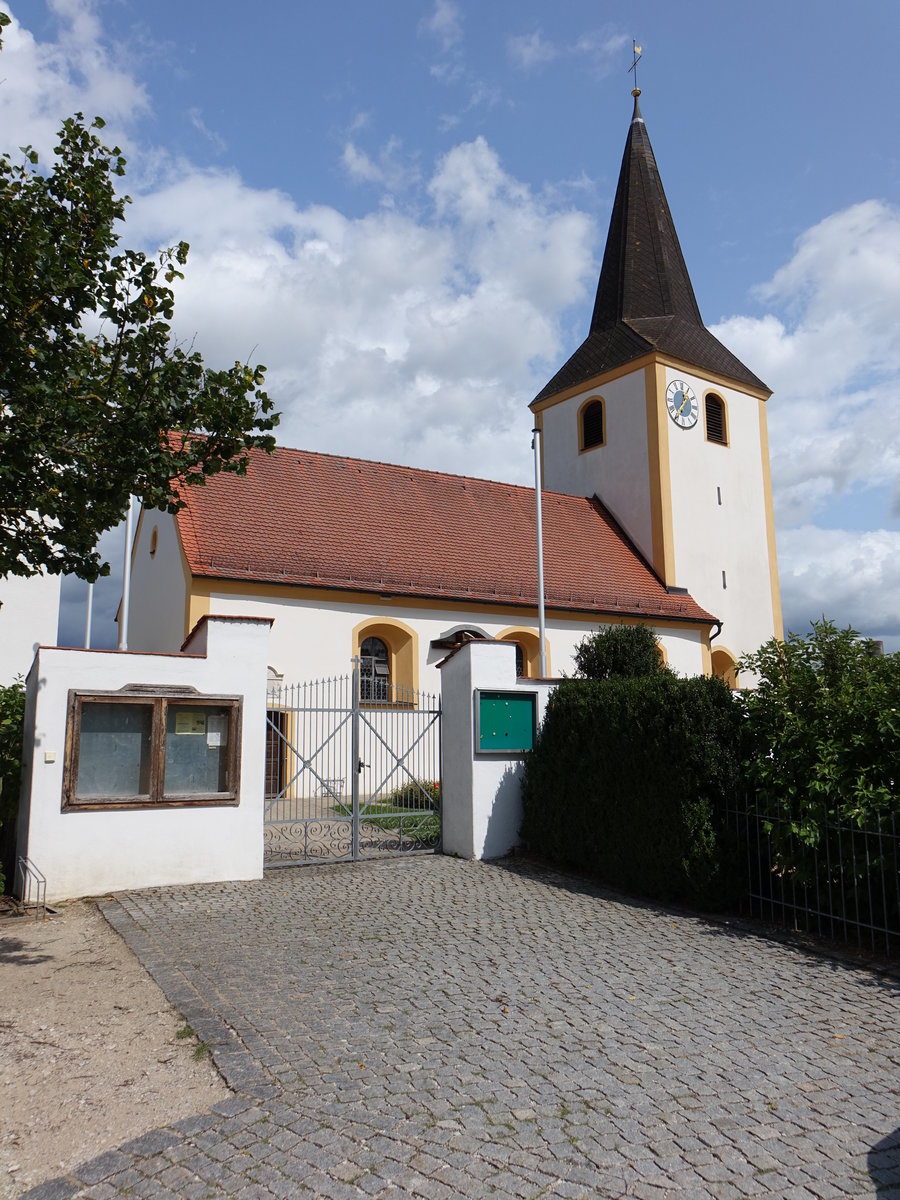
[{"x1": 542, "y1": 367, "x2": 653, "y2": 560}]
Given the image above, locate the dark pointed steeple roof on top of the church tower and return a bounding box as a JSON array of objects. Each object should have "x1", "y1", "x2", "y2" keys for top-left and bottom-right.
[{"x1": 535, "y1": 94, "x2": 768, "y2": 402}]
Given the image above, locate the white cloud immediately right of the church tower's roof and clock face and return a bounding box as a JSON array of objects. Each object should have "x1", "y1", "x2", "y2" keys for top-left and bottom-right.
[{"x1": 714, "y1": 200, "x2": 900, "y2": 524}]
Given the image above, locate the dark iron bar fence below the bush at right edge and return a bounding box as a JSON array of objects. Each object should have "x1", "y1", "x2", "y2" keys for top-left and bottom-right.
[{"x1": 727, "y1": 797, "x2": 900, "y2": 956}]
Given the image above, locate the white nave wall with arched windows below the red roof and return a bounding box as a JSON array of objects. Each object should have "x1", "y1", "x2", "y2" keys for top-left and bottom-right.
[{"x1": 210, "y1": 593, "x2": 703, "y2": 694}]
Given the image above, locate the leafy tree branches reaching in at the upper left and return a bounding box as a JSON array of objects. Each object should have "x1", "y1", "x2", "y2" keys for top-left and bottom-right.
[{"x1": 0, "y1": 112, "x2": 277, "y2": 580}]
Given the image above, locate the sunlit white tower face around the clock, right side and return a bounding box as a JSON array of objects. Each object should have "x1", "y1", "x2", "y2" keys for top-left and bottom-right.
[{"x1": 666, "y1": 367, "x2": 774, "y2": 654}]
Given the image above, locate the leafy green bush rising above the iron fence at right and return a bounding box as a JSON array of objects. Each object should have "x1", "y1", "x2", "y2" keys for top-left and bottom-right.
[{"x1": 739, "y1": 618, "x2": 900, "y2": 845}]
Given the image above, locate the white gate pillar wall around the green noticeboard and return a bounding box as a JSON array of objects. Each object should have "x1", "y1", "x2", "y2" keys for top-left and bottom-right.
[{"x1": 440, "y1": 642, "x2": 557, "y2": 858}]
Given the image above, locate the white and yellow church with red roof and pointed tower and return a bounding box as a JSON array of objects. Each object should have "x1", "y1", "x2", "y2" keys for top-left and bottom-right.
[{"x1": 128, "y1": 91, "x2": 781, "y2": 702}]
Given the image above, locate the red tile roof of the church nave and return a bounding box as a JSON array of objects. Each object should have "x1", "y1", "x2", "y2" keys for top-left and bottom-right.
[{"x1": 176, "y1": 449, "x2": 714, "y2": 623}]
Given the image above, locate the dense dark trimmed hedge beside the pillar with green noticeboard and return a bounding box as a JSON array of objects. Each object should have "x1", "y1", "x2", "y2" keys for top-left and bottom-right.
[{"x1": 522, "y1": 674, "x2": 743, "y2": 907}]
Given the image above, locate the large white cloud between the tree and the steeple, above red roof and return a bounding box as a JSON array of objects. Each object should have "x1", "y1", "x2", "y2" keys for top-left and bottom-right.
[{"x1": 120, "y1": 138, "x2": 595, "y2": 489}]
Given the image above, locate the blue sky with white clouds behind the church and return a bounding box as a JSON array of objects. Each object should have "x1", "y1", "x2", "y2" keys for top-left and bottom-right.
[{"x1": 0, "y1": 0, "x2": 900, "y2": 648}]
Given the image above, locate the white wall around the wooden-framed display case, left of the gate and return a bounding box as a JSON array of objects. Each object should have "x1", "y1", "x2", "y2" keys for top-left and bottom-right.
[{"x1": 19, "y1": 619, "x2": 269, "y2": 901}]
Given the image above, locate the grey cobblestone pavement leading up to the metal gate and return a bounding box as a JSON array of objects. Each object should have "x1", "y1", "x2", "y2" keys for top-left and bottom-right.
[{"x1": 28, "y1": 857, "x2": 900, "y2": 1200}]
